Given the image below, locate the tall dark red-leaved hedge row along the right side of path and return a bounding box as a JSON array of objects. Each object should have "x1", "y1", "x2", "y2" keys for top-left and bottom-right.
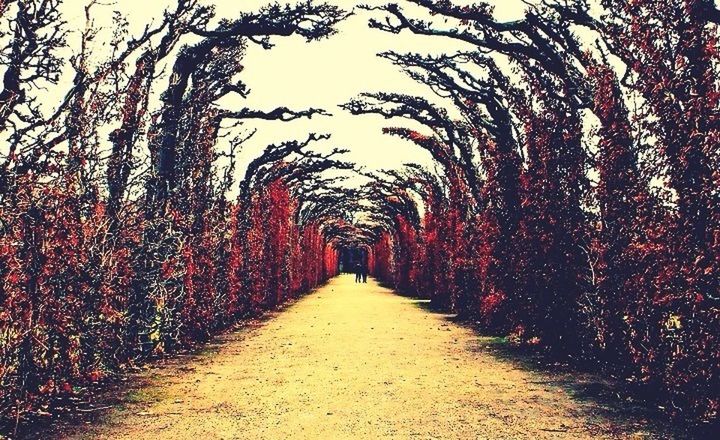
[{"x1": 370, "y1": 0, "x2": 720, "y2": 420}]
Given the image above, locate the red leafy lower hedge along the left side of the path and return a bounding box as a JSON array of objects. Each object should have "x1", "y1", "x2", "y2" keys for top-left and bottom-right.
[{"x1": 0, "y1": 173, "x2": 338, "y2": 426}]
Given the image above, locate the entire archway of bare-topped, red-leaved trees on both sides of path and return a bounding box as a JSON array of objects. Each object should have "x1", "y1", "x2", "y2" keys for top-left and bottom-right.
[{"x1": 0, "y1": 0, "x2": 720, "y2": 428}]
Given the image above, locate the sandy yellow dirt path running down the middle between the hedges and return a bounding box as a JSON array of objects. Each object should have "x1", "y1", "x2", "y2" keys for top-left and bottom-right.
[{"x1": 53, "y1": 275, "x2": 672, "y2": 440}]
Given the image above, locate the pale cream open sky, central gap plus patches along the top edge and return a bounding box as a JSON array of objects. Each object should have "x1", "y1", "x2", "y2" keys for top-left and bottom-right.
[{"x1": 53, "y1": 0, "x2": 524, "y2": 181}]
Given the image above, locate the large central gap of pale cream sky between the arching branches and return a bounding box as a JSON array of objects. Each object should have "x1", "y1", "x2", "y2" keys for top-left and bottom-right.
[{"x1": 233, "y1": 0, "x2": 522, "y2": 172}]
